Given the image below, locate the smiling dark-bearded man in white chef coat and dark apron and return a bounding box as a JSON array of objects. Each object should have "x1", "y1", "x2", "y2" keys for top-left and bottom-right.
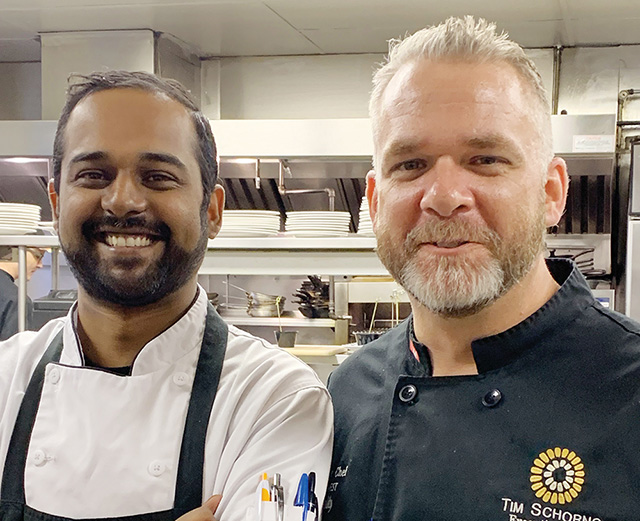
[{"x1": 0, "y1": 71, "x2": 332, "y2": 521}]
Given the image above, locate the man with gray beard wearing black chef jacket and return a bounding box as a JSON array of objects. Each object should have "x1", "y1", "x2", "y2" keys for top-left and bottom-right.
[{"x1": 323, "y1": 17, "x2": 640, "y2": 521}]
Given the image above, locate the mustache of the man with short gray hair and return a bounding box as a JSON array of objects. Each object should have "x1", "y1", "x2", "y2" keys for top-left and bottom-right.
[{"x1": 405, "y1": 219, "x2": 500, "y2": 249}]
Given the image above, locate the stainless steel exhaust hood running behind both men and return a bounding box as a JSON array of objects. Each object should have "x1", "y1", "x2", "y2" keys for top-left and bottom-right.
[{"x1": 0, "y1": 114, "x2": 616, "y2": 233}]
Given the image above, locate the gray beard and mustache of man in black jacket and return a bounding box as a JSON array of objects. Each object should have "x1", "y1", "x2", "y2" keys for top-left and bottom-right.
[{"x1": 376, "y1": 208, "x2": 545, "y2": 318}]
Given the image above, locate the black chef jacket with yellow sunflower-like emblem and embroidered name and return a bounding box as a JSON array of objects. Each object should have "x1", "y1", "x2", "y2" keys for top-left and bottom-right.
[{"x1": 323, "y1": 261, "x2": 640, "y2": 521}]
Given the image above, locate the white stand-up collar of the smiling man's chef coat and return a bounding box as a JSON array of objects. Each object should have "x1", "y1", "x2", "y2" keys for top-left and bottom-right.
[{"x1": 60, "y1": 286, "x2": 208, "y2": 376}]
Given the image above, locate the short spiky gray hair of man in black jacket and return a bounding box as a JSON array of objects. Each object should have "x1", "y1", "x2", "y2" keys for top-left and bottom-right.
[{"x1": 369, "y1": 15, "x2": 553, "y2": 166}]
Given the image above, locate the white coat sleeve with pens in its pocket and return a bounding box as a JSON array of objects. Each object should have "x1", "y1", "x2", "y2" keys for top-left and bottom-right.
[{"x1": 213, "y1": 385, "x2": 333, "y2": 521}]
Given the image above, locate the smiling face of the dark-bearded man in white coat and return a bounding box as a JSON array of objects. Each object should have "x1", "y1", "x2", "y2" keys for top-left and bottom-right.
[{"x1": 52, "y1": 88, "x2": 223, "y2": 306}]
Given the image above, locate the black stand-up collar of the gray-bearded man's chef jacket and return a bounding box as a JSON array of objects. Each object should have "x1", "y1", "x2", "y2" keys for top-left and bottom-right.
[{"x1": 405, "y1": 259, "x2": 597, "y2": 374}]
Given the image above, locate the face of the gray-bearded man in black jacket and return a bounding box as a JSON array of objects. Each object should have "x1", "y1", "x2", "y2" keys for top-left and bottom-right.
[{"x1": 367, "y1": 60, "x2": 566, "y2": 316}]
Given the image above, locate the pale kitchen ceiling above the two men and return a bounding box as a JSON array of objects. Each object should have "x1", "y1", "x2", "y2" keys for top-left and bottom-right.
[{"x1": 0, "y1": 0, "x2": 640, "y2": 62}]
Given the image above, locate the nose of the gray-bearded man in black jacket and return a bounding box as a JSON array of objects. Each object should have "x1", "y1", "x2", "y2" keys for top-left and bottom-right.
[{"x1": 420, "y1": 156, "x2": 474, "y2": 217}]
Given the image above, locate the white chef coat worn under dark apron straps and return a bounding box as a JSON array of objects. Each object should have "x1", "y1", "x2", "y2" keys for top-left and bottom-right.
[{"x1": 0, "y1": 289, "x2": 333, "y2": 521}]
